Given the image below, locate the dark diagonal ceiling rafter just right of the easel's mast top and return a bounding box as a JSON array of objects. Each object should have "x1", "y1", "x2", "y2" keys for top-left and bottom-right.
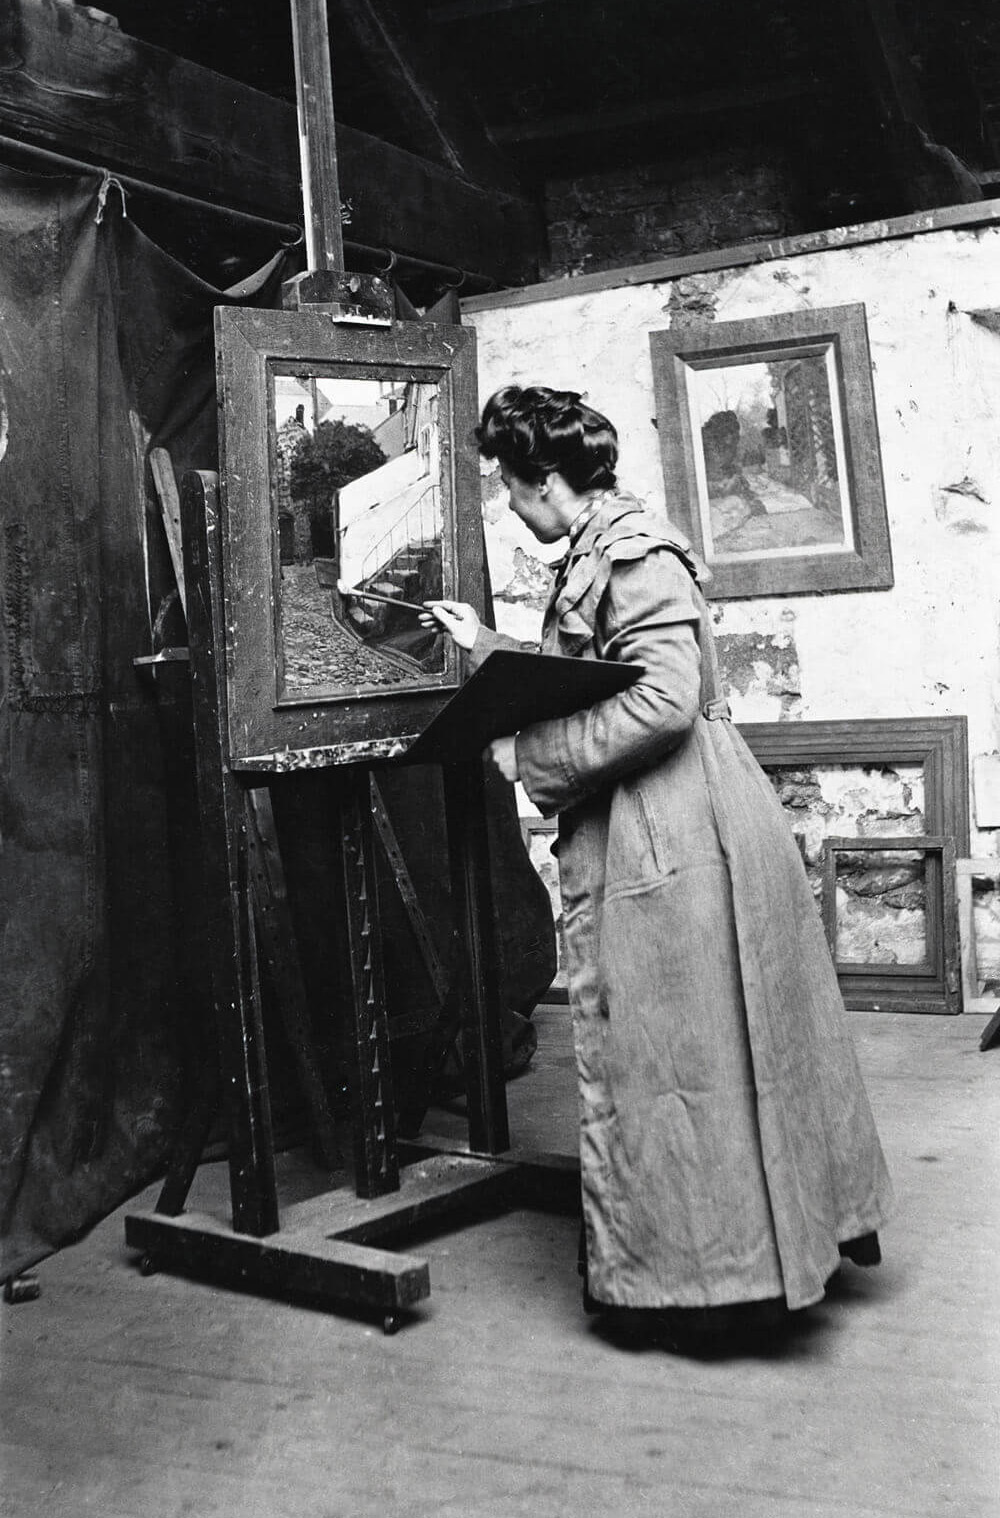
[{"x1": 331, "y1": 0, "x2": 528, "y2": 193}]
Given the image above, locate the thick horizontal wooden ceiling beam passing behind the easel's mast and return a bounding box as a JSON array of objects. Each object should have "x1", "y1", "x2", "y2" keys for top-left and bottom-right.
[{"x1": 0, "y1": 0, "x2": 542, "y2": 284}]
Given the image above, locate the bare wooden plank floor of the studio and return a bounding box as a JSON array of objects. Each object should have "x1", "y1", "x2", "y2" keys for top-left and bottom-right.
[{"x1": 0, "y1": 1008, "x2": 1000, "y2": 1518}]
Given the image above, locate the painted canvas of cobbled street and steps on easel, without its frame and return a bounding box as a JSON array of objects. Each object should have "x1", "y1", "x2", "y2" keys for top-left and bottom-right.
[{"x1": 272, "y1": 373, "x2": 451, "y2": 698}]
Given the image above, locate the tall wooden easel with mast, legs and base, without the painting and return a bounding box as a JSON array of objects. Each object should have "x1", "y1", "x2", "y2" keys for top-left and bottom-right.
[{"x1": 126, "y1": 0, "x2": 578, "y2": 1331}]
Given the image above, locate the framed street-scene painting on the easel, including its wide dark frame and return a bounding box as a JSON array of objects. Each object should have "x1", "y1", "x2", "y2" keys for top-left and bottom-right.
[{"x1": 215, "y1": 308, "x2": 484, "y2": 770}]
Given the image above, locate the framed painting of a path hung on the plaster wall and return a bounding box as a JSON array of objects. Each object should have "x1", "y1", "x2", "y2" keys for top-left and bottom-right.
[{"x1": 649, "y1": 305, "x2": 892, "y2": 600}]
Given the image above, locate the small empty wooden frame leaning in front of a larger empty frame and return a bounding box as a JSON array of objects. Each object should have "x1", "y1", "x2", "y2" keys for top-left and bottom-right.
[{"x1": 822, "y1": 833, "x2": 962, "y2": 1014}]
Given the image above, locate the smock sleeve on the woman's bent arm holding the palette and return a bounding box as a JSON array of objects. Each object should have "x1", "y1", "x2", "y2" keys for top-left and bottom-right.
[{"x1": 517, "y1": 548, "x2": 701, "y2": 817}]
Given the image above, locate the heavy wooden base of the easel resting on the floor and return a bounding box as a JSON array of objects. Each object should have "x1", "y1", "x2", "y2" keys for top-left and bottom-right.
[{"x1": 124, "y1": 1143, "x2": 580, "y2": 1333}]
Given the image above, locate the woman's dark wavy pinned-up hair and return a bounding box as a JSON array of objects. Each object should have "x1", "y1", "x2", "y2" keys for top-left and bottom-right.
[{"x1": 475, "y1": 384, "x2": 618, "y2": 495}]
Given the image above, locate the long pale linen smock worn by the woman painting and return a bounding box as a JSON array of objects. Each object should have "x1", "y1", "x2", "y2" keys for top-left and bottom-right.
[{"x1": 470, "y1": 493, "x2": 891, "y2": 1309}]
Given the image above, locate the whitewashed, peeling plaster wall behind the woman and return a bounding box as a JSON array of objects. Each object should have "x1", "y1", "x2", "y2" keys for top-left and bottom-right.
[{"x1": 464, "y1": 226, "x2": 1000, "y2": 855}]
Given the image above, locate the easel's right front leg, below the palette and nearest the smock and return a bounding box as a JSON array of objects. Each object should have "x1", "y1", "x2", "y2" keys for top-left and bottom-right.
[{"x1": 445, "y1": 761, "x2": 510, "y2": 1154}]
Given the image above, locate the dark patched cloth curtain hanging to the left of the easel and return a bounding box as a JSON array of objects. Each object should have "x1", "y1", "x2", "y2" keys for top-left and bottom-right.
[{"x1": 0, "y1": 168, "x2": 289, "y2": 1278}]
